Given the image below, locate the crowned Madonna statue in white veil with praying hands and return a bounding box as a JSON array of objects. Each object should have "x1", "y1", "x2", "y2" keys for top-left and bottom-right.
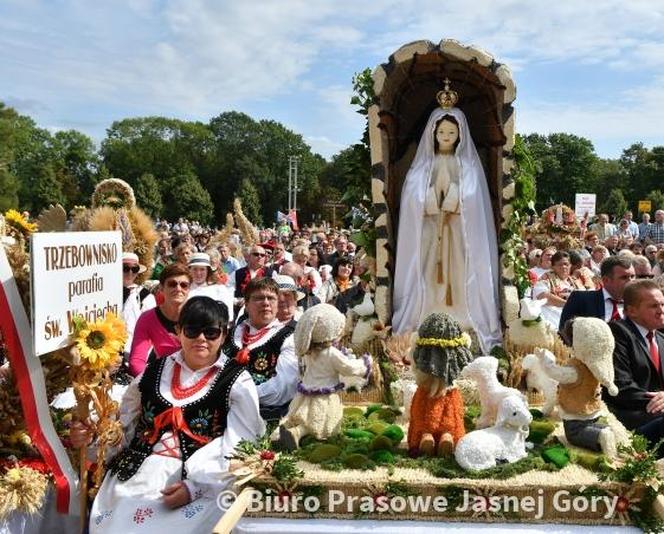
[{"x1": 392, "y1": 82, "x2": 502, "y2": 353}]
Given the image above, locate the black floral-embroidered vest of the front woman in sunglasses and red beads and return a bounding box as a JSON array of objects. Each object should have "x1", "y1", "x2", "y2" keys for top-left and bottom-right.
[{"x1": 108, "y1": 358, "x2": 244, "y2": 481}]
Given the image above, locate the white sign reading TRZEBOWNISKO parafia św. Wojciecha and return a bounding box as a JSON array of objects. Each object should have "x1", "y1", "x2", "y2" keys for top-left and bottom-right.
[{"x1": 31, "y1": 232, "x2": 122, "y2": 356}]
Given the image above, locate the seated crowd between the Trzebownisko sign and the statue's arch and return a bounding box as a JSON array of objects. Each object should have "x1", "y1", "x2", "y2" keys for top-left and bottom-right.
[{"x1": 70, "y1": 220, "x2": 374, "y2": 532}]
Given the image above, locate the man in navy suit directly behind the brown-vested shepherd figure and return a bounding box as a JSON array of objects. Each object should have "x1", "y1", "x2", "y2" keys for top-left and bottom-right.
[{"x1": 558, "y1": 256, "x2": 634, "y2": 331}]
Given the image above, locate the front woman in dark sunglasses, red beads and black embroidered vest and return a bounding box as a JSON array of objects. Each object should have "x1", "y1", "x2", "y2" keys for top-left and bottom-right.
[{"x1": 70, "y1": 296, "x2": 265, "y2": 533}]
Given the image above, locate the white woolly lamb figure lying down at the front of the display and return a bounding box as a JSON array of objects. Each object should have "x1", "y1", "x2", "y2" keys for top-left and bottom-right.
[{"x1": 454, "y1": 395, "x2": 533, "y2": 471}]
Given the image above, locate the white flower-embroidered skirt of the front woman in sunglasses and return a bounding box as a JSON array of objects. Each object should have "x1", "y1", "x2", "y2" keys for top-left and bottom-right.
[{"x1": 90, "y1": 454, "x2": 223, "y2": 534}]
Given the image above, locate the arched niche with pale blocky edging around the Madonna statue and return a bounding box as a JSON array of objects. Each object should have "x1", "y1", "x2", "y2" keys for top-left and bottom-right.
[{"x1": 369, "y1": 40, "x2": 516, "y2": 322}]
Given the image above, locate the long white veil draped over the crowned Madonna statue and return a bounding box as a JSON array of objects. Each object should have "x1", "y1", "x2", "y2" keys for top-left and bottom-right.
[{"x1": 392, "y1": 108, "x2": 502, "y2": 354}]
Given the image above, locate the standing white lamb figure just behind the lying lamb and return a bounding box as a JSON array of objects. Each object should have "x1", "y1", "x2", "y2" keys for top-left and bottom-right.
[{"x1": 461, "y1": 356, "x2": 526, "y2": 428}]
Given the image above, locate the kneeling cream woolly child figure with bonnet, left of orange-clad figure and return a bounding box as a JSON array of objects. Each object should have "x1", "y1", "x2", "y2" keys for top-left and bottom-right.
[{"x1": 279, "y1": 304, "x2": 371, "y2": 450}]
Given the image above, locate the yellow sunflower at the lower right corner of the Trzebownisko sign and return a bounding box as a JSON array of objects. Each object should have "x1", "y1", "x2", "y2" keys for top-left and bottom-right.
[{"x1": 75, "y1": 313, "x2": 127, "y2": 369}]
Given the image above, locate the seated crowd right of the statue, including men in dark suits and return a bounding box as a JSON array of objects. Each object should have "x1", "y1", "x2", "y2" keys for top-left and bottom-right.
[{"x1": 528, "y1": 210, "x2": 664, "y2": 457}]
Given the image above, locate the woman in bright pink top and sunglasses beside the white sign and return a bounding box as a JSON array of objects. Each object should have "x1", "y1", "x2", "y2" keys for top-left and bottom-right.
[{"x1": 129, "y1": 263, "x2": 191, "y2": 376}]
